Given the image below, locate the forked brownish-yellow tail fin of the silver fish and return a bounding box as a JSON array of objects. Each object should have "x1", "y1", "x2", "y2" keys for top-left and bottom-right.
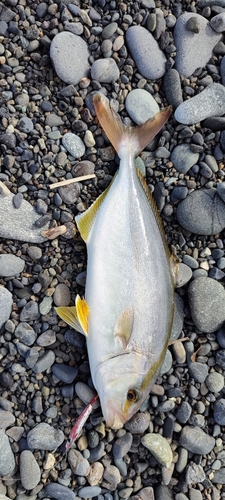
[{"x1": 93, "y1": 94, "x2": 172, "y2": 156}]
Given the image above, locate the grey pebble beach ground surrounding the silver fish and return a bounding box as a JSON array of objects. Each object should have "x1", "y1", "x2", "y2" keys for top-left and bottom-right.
[{"x1": 0, "y1": 0, "x2": 225, "y2": 500}]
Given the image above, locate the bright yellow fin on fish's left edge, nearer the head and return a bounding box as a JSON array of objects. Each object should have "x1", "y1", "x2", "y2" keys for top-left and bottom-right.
[{"x1": 55, "y1": 295, "x2": 89, "y2": 336}]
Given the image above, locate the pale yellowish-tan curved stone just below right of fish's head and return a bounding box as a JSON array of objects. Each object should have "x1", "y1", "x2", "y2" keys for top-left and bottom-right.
[{"x1": 141, "y1": 433, "x2": 173, "y2": 467}]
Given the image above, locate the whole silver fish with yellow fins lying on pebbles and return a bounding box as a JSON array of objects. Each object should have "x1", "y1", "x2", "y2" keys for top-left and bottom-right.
[{"x1": 56, "y1": 94, "x2": 178, "y2": 429}]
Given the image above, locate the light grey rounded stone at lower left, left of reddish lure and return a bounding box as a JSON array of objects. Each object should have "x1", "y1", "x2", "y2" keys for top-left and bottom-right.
[{"x1": 27, "y1": 422, "x2": 64, "y2": 451}]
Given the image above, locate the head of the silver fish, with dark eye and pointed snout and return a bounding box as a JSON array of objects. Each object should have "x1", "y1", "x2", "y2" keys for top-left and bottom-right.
[{"x1": 94, "y1": 352, "x2": 158, "y2": 429}]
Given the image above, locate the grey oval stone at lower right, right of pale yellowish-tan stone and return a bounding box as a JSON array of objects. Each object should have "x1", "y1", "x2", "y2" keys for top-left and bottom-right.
[{"x1": 179, "y1": 425, "x2": 215, "y2": 455}]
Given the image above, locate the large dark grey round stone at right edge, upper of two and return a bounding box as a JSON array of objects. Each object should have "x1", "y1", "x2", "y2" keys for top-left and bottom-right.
[{"x1": 177, "y1": 188, "x2": 225, "y2": 236}]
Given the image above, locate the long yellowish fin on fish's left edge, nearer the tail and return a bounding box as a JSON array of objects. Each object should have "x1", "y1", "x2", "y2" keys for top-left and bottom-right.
[{"x1": 75, "y1": 176, "x2": 116, "y2": 243}]
